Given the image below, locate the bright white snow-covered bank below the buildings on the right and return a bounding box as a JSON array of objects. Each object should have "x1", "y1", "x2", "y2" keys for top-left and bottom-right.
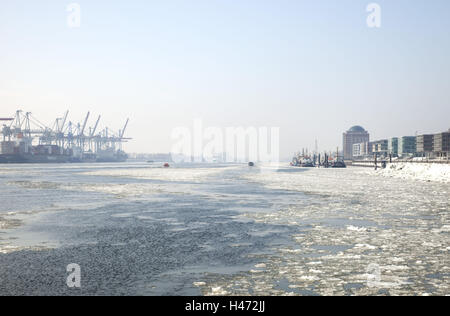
[{"x1": 377, "y1": 163, "x2": 450, "y2": 183}]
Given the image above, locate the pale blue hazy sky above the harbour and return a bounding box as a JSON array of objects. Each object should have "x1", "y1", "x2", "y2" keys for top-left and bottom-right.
[{"x1": 0, "y1": 0, "x2": 450, "y2": 157}]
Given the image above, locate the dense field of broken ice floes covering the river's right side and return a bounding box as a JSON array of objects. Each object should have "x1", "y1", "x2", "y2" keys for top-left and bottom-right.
[{"x1": 195, "y1": 168, "x2": 450, "y2": 295}]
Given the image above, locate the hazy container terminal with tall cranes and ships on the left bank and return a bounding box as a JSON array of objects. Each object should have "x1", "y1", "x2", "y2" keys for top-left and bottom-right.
[{"x1": 0, "y1": 110, "x2": 131, "y2": 163}]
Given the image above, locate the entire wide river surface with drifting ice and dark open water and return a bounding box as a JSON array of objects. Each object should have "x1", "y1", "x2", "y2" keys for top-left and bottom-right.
[{"x1": 0, "y1": 163, "x2": 450, "y2": 295}]
